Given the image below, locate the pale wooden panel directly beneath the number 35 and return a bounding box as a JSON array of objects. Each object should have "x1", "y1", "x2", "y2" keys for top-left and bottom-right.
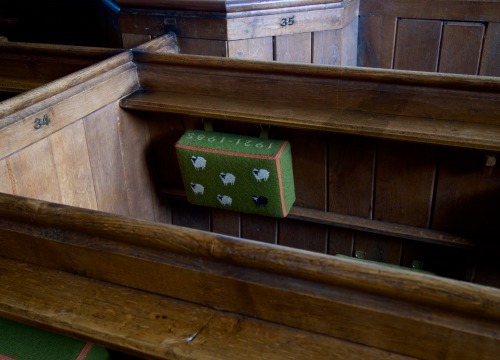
[{"x1": 274, "y1": 33, "x2": 312, "y2": 63}]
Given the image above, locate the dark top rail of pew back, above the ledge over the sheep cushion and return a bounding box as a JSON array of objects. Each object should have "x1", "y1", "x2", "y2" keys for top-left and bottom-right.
[{"x1": 135, "y1": 53, "x2": 499, "y2": 124}]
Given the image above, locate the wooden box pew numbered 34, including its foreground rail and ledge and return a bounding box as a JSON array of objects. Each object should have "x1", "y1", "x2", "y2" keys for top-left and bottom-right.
[{"x1": 0, "y1": 33, "x2": 500, "y2": 359}]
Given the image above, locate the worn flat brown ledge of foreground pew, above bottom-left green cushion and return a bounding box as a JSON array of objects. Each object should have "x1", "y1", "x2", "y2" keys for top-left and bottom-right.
[{"x1": 0, "y1": 258, "x2": 414, "y2": 359}]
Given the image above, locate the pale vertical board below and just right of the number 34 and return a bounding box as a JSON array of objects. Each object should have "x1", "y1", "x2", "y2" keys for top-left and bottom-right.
[{"x1": 49, "y1": 121, "x2": 97, "y2": 209}]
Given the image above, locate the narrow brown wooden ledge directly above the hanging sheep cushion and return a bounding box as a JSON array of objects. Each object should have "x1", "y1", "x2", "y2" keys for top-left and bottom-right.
[{"x1": 120, "y1": 91, "x2": 500, "y2": 151}]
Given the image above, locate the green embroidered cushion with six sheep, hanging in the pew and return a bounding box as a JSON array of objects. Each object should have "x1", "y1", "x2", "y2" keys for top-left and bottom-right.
[{"x1": 176, "y1": 130, "x2": 295, "y2": 217}]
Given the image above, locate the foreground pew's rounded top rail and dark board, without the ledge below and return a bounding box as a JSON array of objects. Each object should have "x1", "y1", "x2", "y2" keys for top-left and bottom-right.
[{"x1": 0, "y1": 195, "x2": 500, "y2": 359}]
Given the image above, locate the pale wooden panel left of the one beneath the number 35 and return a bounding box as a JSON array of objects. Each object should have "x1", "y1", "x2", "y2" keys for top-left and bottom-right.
[{"x1": 227, "y1": 36, "x2": 274, "y2": 61}]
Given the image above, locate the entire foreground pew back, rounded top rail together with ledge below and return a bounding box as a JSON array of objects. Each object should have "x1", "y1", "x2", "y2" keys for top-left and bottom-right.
[{"x1": 0, "y1": 195, "x2": 500, "y2": 359}]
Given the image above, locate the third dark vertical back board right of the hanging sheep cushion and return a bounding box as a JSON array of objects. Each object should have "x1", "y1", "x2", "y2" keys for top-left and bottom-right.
[{"x1": 374, "y1": 142, "x2": 435, "y2": 227}]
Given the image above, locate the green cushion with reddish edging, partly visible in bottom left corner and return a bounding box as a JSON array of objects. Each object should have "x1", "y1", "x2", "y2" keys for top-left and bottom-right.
[{"x1": 0, "y1": 318, "x2": 109, "y2": 360}]
